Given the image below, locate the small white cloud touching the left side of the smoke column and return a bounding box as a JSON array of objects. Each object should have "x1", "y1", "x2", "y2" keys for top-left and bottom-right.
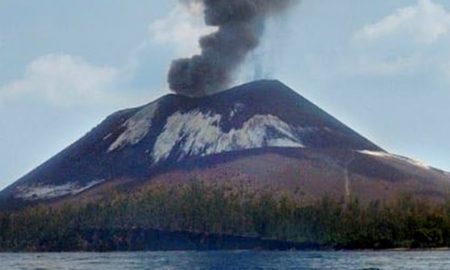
[{"x1": 149, "y1": 1, "x2": 216, "y2": 56}]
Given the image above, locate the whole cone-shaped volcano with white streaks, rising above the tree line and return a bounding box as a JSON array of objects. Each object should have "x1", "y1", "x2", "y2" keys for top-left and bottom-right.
[{"x1": 0, "y1": 81, "x2": 450, "y2": 208}]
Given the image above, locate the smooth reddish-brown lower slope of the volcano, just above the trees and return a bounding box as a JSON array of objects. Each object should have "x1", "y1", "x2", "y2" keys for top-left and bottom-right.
[{"x1": 64, "y1": 148, "x2": 450, "y2": 203}]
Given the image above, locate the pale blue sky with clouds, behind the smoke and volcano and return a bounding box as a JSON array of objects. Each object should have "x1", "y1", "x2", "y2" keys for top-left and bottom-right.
[{"x1": 0, "y1": 0, "x2": 450, "y2": 189}]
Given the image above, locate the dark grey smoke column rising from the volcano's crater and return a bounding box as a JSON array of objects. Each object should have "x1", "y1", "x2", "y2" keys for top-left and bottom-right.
[{"x1": 168, "y1": 0, "x2": 298, "y2": 96}]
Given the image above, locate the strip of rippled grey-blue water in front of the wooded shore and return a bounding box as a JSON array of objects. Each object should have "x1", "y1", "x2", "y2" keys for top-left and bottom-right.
[{"x1": 0, "y1": 251, "x2": 450, "y2": 270}]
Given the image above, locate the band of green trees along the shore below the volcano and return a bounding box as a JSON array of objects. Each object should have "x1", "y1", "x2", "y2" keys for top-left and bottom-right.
[{"x1": 0, "y1": 181, "x2": 450, "y2": 251}]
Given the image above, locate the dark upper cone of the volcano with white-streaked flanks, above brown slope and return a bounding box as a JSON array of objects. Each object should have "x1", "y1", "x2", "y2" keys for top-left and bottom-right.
[{"x1": 0, "y1": 81, "x2": 449, "y2": 207}]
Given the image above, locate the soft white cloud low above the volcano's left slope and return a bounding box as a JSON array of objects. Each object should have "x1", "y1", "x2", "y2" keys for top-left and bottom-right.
[{"x1": 0, "y1": 54, "x2": 119, "y2": 107}]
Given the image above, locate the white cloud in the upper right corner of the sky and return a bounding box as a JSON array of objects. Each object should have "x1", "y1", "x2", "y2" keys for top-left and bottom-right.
[{"x1": 356, "y1": 0, "x2": 450, "y2": 44}]
